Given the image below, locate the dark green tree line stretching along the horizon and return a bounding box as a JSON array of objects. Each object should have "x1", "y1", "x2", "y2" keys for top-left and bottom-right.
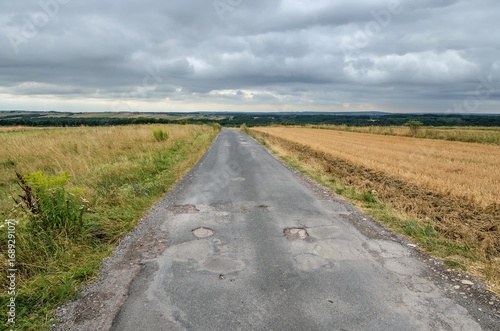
[{"x1": 0, "y1": 113, "x2": 500, "y2": 127}]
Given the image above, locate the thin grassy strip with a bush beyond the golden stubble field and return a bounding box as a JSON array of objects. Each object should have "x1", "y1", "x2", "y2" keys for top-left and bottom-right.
[{"x1": 307, "y1": 124, "x2": 500, "y2": 145}]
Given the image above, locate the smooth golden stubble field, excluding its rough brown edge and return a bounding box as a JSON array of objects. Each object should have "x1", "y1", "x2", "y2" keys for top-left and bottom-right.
[{"x1": 252, "y1": 127, "x2": 500, "y2": 206}]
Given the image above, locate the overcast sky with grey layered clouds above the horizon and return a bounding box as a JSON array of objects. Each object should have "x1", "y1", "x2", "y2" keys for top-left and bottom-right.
[{"x1": 0, "y1": 0, "x2": 500, "y2": 113}]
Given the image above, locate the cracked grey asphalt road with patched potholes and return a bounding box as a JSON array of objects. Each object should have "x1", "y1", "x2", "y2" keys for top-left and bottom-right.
[{"x1": 112, "y1": 130, "x2": 488, "y2": 331}]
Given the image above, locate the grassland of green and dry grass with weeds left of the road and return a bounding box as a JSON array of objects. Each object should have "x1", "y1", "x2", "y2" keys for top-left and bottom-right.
[{"x1": 0, "y1": 125, "x2": 220, "y2": 330}]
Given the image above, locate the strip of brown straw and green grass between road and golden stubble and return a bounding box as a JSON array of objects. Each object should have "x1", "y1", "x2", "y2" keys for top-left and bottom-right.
[{"x1": 246, "y1": 130, "x2": 500, "y2": 295}]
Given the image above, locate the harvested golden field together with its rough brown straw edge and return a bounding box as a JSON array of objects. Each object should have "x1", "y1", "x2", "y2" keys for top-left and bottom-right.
[{"x1": 251, "y1": 127, "x2": 500, "y2": 294}]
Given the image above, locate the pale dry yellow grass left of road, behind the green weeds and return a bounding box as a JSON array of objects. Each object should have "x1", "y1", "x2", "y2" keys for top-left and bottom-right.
[{"x1": 0, "y1": 125, "x2": 207, "y2": 216}]
